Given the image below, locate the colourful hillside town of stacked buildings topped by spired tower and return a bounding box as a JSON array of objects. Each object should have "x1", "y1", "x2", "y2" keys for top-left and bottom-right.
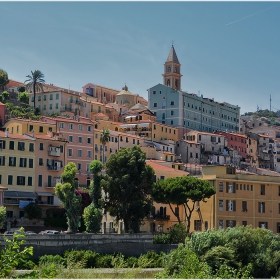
[{"x1": 0, "y1": 45, "x2": 280, "y2": 234}]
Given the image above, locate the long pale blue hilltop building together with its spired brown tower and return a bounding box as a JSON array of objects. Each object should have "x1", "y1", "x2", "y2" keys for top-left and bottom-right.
[{"x1": 148, "y1": 46, "x2": 240, "y2": 132}]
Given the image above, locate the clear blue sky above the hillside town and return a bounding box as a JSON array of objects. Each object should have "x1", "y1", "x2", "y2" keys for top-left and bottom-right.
[{"x1": 0, "y1": 2, "x2": 280, "y2": 113}]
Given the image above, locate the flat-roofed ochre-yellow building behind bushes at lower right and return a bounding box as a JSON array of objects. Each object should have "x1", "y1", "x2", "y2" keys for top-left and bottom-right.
[{"x1": 196, "y1": 166, "x2": 280, "y2": 233}]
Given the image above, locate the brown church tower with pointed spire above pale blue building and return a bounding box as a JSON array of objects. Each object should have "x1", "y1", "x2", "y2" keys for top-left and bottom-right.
[{"x1": 162, "y1": 45, "x2": 182, "y2": 90}]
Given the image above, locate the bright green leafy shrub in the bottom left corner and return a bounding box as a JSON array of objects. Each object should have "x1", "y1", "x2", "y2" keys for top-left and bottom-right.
[{"x1": 0, "y1": 228, "x2": 33, "y2": 278}]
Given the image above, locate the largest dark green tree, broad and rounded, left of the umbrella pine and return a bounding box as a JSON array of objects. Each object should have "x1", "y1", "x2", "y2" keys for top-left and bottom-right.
[{"x1": 101, "y1": 146, "x2": 154, "y2": 232}]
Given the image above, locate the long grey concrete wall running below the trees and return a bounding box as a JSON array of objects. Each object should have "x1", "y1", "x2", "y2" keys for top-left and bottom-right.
[{"x1": 0, "y1": 234, "x2": 178, "y2": 258}]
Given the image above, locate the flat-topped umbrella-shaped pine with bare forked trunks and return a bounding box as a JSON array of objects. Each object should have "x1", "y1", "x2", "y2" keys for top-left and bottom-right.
[{"x1": 152, "y1": 176, "x2": 216, "y2": 233}]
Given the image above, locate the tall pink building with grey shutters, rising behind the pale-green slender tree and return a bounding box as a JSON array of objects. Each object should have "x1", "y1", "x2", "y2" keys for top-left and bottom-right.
[{"x1": 41, "y1": 116, "x2": 95, "y2": 187}]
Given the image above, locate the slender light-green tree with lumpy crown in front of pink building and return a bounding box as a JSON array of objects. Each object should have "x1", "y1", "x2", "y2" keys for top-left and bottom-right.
[{"x1": 55, "y1": 162, "x2": 81, "y2": 232}]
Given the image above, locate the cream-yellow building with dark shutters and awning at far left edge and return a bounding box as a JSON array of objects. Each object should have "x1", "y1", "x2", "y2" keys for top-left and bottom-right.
[{"x1": 0, "y1": 131, "x2": 36, "y2": 219}]
